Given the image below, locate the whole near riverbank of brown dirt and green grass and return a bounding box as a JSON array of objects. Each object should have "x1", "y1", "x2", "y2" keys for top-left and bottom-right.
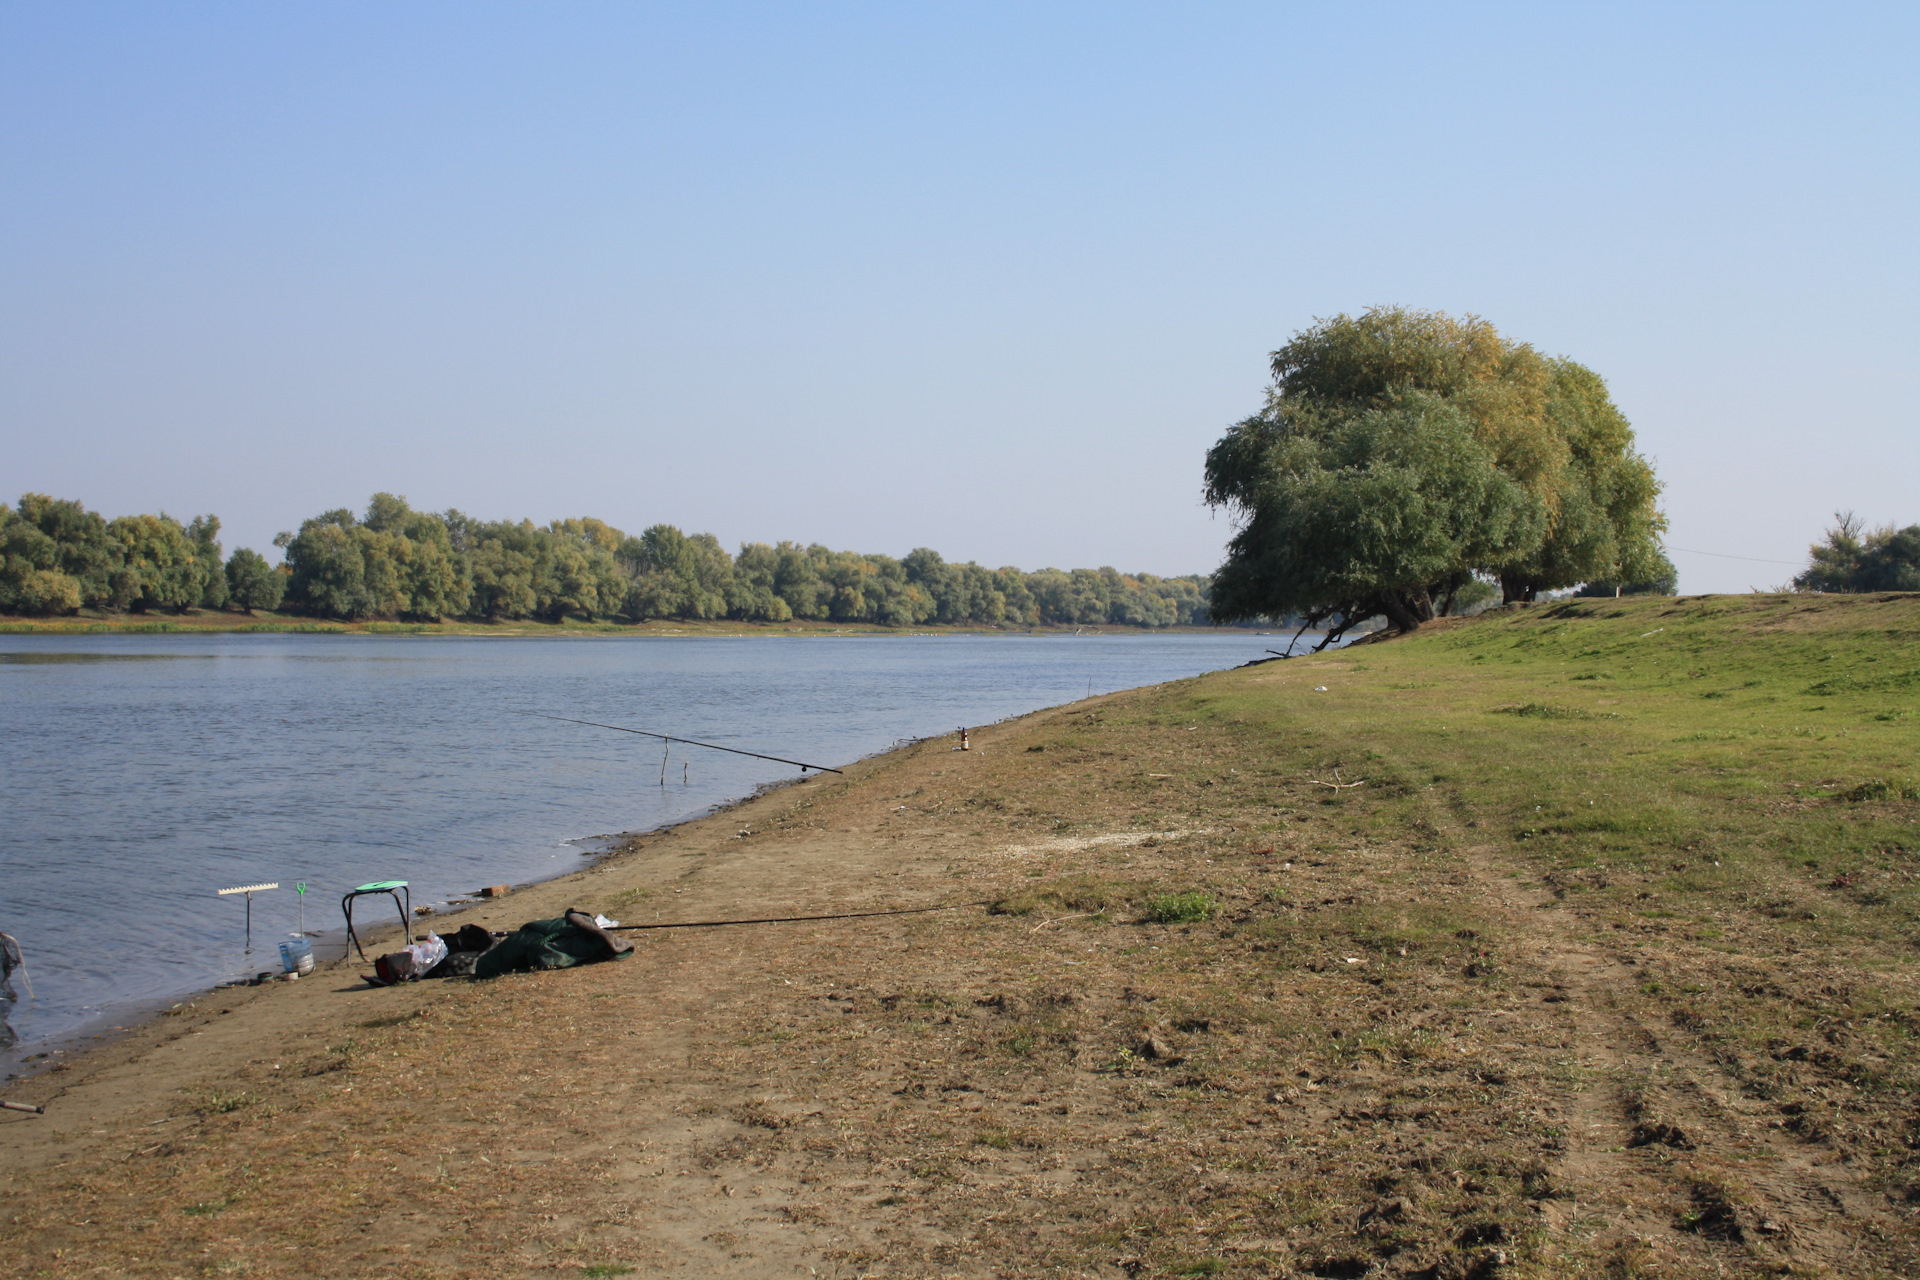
[{"x1": 0, "y1": 597, "x2": 1920, "y2": 1280}]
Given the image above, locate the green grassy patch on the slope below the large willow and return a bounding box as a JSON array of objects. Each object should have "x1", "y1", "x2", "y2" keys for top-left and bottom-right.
[{"x1": 1194, "y1": 595, "x2": 1920, "y2": 940}]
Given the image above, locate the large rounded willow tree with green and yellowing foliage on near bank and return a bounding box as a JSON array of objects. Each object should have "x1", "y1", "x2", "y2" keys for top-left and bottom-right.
[{"x1": 1206, "y1": 307, "x2": 1665, "y2": 639}]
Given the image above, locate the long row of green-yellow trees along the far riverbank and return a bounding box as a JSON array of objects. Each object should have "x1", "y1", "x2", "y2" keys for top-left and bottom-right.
[{"x1": 0, "y1": 493, "x2": 1212, "y2": 628}]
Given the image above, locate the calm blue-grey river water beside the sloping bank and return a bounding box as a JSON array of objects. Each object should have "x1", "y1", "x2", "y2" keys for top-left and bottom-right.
[{"x1": 0, "y1": 631, "x2": 1273, "y2": 1071}]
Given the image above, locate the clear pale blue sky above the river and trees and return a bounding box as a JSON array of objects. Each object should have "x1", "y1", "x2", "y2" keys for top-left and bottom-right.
[{"x1": 0, "y1": 0, "x2": 1920, "y2": 591}]
